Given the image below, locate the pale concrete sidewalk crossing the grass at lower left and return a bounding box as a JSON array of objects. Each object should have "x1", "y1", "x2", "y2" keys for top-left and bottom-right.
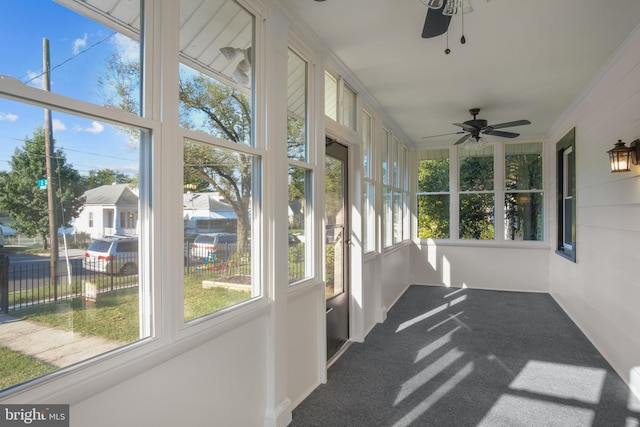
[{"x1": 0, "y1": 315, "x2": 124, "y2": 368}]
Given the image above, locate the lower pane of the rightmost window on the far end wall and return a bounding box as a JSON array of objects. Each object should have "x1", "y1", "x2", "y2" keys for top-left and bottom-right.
[{"x1": 504, "y1": 192, "x2": 544, "y2": 240}]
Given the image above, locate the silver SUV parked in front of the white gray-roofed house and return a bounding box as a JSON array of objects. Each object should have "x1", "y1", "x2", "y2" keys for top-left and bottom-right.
[{"x1": 82, "y1": 237, "x2": 138, "y2": 276}]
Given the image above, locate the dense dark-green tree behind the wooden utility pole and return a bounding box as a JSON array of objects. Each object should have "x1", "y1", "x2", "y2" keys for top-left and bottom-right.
[{"x1": 0, "y1": 128, "x2": 84, "y2": 249}]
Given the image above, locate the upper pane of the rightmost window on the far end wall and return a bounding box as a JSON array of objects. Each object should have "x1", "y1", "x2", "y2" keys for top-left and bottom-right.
[{"x1": 505, "y1": 142, "x2": 542, "y2": 190}]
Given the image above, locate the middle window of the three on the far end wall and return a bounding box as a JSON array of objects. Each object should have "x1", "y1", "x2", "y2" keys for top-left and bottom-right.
[{"x1": 458, "y1": 145, "x2": 495, "y2": 240}]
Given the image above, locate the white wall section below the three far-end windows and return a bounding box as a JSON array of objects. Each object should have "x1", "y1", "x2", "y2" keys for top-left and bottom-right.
[{"x1": 412, "y1": 243, "x2": 549, "y2": 292}]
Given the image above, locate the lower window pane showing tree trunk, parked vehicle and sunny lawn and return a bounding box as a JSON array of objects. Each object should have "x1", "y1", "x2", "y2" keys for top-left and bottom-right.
[{"x1": 183, "y1": 139, "x2": 259, "y2": 321}]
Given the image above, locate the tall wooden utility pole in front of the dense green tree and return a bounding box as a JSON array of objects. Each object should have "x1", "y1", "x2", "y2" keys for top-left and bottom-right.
[{"x1": 42, "y1": 38, "x2": 58, "y2": 300}]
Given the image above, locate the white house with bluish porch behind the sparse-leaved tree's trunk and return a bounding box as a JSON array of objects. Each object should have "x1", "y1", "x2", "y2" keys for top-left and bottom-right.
[{"x1": 182, "y1": 192, "x2": 237, "y2": 235}]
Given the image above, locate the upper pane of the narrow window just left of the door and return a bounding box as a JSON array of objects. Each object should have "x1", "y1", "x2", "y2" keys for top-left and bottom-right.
[{"x1": 287, "y1": 49, "x2": 307, "y2": 161}]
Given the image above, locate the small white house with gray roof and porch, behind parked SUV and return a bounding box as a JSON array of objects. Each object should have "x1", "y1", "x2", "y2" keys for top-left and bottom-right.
[{"x1": 74, "y1": 184, "x2": 138, "y2": 239}]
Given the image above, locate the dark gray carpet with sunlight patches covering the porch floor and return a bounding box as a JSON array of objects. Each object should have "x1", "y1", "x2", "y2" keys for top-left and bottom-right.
[{"x1": 290, "y1": 286, "x2": 640, "y2": 427}]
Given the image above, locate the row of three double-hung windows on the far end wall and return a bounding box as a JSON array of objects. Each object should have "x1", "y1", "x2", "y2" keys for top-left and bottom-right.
[{"x1": 417, "y1": 142, "x2": 545, "y2": 242}]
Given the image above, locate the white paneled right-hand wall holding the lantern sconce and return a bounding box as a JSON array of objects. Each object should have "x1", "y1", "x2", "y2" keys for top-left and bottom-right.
[{"x1": 549, "y1": 27, "x2": 640, "y2": 387}]
